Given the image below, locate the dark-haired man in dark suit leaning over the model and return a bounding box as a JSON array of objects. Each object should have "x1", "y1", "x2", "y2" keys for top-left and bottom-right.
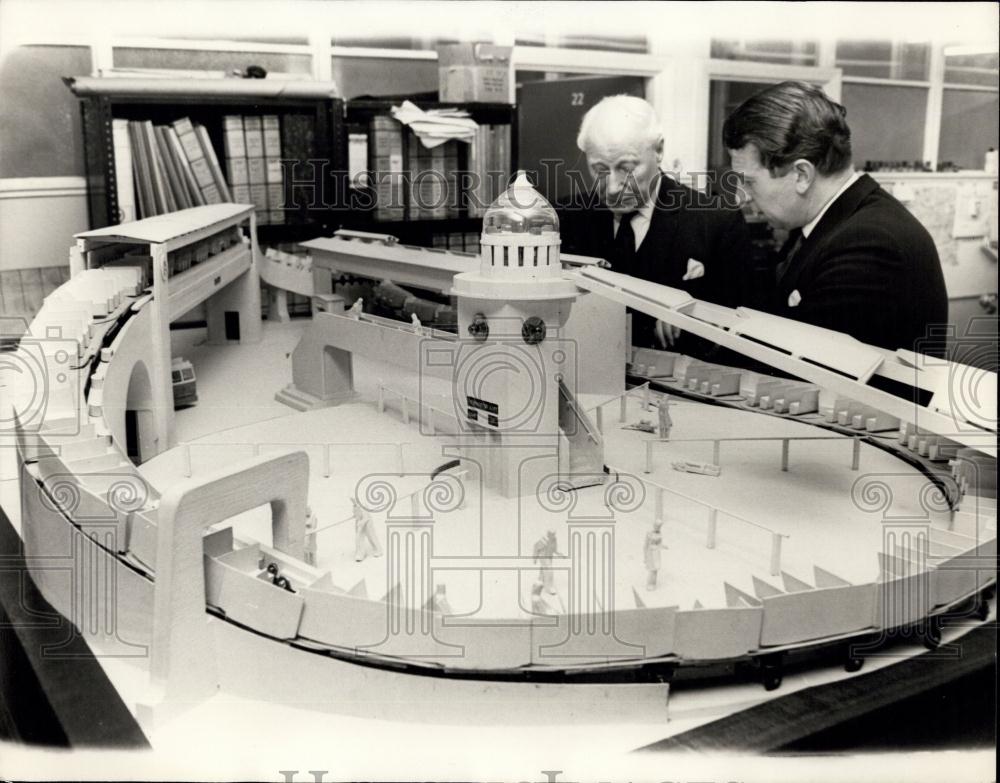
[{"x1": 722, "y1": 82, "x2": 948, "y2": 350}]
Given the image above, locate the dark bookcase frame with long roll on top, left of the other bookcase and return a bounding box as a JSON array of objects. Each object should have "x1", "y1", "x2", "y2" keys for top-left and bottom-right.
[{"x1": 65, "y1": 78, "x2": 347, "y2": 244}]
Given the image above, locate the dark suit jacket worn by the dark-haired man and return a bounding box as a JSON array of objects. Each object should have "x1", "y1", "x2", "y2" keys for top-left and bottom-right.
[{"x1": 768, "y1": 174, "x2": 948, "y2": 353}]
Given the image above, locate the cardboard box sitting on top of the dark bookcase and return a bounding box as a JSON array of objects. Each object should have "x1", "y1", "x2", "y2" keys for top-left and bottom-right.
[{"x1": 437, "y1": 43, "x2": 513, "y2": 103}]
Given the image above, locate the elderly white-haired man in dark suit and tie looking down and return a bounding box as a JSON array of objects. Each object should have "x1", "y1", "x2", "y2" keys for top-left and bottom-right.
[{"x1": 560, "y1": 95, "x2": 750, "y2": 352}]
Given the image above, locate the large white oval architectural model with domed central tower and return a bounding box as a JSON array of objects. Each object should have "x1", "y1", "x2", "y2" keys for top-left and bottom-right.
[{"x1": 3, "y1": 175, "x2": 997, "y2": 726}]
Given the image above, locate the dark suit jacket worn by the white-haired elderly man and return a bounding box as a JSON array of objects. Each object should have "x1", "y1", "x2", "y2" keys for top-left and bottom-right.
[{"x1": 559, "y1": 175, "x2": 750, "y2": 348}]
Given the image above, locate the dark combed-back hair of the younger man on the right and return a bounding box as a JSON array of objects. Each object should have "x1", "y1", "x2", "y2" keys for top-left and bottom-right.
[{"x1": 722, "y1": 82, "x2": 851, "y2": 175}]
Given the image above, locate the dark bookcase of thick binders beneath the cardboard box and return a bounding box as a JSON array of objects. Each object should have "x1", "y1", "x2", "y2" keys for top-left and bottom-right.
[{"x1": 342, "y1": 97, "x2": 518, "y2": 250}]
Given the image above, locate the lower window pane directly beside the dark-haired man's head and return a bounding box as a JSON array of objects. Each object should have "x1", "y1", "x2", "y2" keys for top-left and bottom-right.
[{"x1": 842, "y1": 82, "x2": 927, "y2": 169}]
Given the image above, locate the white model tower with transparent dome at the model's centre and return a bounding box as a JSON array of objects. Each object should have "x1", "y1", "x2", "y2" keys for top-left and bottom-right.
[{"x1": 452, "y1": 172, "x2": 579, "y2": 497}]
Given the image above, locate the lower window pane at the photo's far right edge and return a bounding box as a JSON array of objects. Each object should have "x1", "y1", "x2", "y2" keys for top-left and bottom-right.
[{"x1": 938, "y1": 90, "x2": 1000, "y2": 169}]
